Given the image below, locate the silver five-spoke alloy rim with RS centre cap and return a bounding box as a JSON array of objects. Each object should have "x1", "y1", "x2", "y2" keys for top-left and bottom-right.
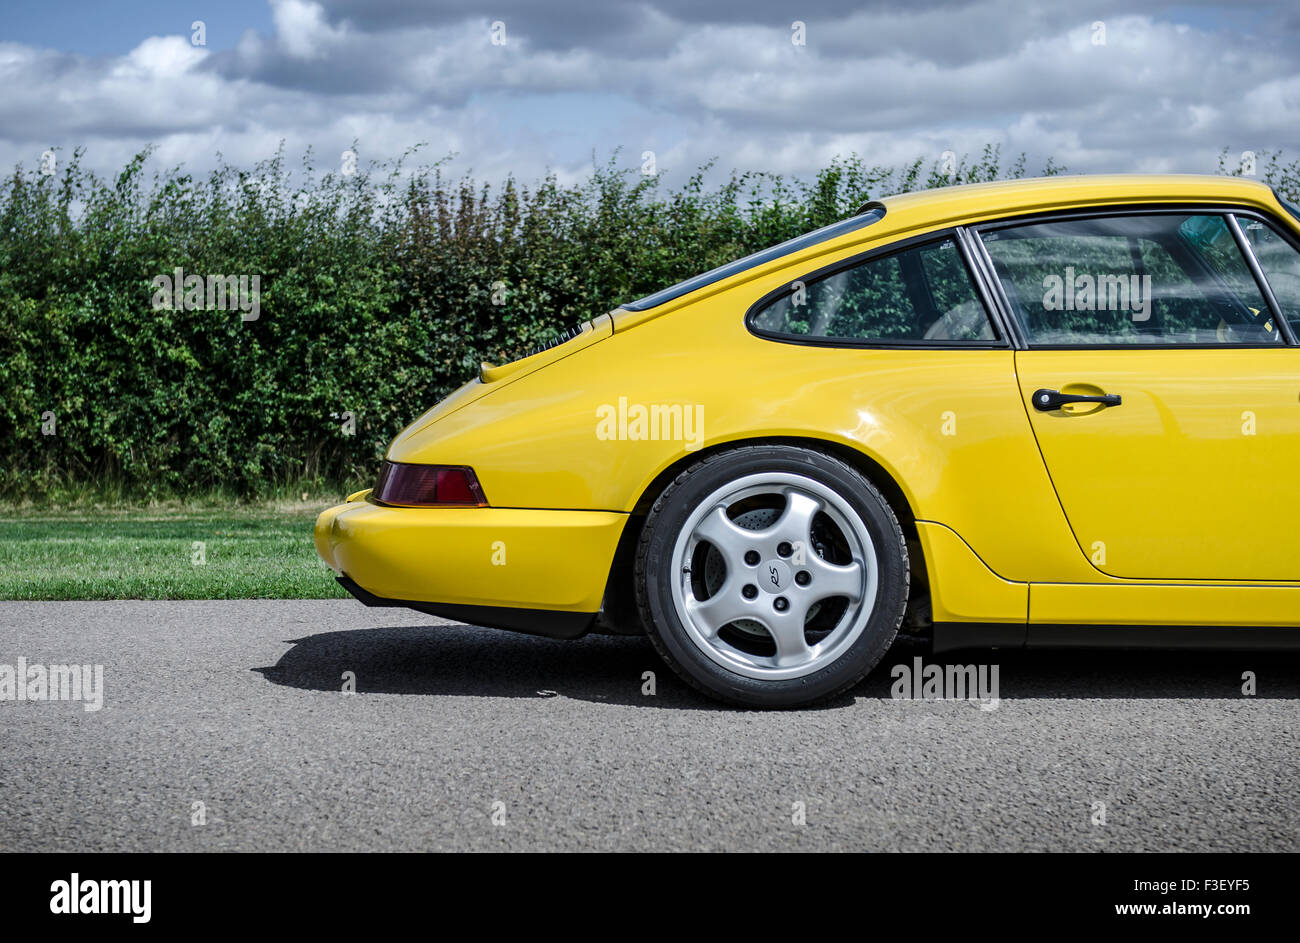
[{"x1": 672, "y1": 472, "x2": 879, "y2": 682}]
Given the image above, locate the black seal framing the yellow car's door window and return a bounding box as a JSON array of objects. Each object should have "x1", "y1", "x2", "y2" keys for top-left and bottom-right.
[{"x1": 966, "y1": 202, "x2": 1296, "y2": 350}]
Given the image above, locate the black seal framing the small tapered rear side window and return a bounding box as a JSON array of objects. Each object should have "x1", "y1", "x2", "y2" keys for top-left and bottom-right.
[{"x1": 745, "y1": 226, "x2": 1011, "y2": 350}]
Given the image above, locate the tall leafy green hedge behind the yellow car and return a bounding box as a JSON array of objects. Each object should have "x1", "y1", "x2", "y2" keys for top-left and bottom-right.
[{"x1": 0, "y1": 141, "x2": 1289, "y2": 501}]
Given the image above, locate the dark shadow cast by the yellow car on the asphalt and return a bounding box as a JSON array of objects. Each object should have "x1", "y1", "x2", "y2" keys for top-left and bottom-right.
[{"x1": 254, "y1": 624, "x2": 1300, "y2": 710}]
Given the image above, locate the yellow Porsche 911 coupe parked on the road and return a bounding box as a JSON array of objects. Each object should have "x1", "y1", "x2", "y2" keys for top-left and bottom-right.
[{"x1": 316, "y1": 176, "x2": 1300, "y2": 706}]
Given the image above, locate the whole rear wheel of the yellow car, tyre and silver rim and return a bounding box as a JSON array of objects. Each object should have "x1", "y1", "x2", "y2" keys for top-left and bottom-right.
[{"x1": 636, "y1": 446, "x2": 909, "y2": 706}]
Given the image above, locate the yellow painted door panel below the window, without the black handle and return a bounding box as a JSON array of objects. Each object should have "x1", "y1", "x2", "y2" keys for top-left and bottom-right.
[{"x1": 1015, "y1": 347, "x2": 1300, "y2": 580}]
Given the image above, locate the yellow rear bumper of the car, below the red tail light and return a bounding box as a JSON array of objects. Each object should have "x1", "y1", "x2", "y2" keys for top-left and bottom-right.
[{"x1": 316, "y1": 499, "x2": 627, "y2": 637}]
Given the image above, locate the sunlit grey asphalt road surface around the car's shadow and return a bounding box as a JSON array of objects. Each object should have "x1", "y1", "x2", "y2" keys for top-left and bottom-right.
[{"x1": 0, "y1": 601, "x2": 1300, "y2": 851}]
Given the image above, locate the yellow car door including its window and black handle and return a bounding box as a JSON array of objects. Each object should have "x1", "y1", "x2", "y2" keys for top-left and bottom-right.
[{"x1": 980, "y1": 209, "x2": 1300, "y2": 580}]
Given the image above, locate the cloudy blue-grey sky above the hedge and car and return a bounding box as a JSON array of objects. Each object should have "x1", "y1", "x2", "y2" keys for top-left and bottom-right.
[{"x1": 0, "y1": 0, "x2": 1300, "y2": 192}]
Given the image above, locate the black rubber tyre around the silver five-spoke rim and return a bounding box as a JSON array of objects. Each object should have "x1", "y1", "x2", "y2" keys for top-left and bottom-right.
[{"x1": 634, "y1": 445, "x2": 910, "y2": 708}]
